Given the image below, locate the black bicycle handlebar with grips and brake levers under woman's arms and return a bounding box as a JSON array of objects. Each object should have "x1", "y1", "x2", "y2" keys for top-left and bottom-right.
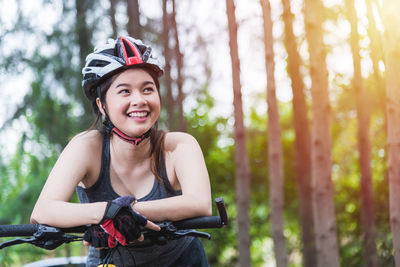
[{"x1": 0, "y1": 197, "x2": 228, "y2": 266}]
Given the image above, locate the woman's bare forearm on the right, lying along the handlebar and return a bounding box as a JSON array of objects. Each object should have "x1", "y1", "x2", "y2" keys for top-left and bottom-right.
[{"x1": 133, "y1": 195, "x2": 212, "y2": 222}]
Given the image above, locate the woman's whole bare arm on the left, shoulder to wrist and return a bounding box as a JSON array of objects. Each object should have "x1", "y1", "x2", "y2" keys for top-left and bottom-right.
[{"x1": 31, "y1": 131, "x2": 107, "y2": 227}]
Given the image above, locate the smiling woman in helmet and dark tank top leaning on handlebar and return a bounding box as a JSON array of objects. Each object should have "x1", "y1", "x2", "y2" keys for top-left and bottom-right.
[{"x1": 31, "y1": 37, "x2": 211, "y2": 266}]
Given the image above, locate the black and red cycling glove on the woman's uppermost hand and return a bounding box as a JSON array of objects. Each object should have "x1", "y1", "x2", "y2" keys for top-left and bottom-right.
[{"x1": 100, "y1": 196, "x2": 147, "y2": 247}]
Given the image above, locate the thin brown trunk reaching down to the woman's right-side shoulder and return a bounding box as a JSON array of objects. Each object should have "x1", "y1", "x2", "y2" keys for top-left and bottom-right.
[{"x1": 171, "y1": 0, "x2": 186, "y2": 132}]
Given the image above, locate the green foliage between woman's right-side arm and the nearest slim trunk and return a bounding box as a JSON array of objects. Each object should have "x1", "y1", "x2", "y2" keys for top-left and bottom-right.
[{"x1": 186, "y1": 87, "x2": 237, "y2": 266}]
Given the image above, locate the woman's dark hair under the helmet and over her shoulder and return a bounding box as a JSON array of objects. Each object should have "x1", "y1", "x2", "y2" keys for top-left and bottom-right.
[{"x1": 89, "y1": 66, "x2": 166, "y2": 182}]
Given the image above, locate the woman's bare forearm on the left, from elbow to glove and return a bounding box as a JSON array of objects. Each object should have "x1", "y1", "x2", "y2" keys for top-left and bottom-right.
[{"x1": 31, "y1": 200, "x2": 107, "y2": 228}]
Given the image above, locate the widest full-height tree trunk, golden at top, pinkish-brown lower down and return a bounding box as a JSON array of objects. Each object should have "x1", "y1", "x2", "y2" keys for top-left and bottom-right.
[{"x1": 304, "y1": 0, "x2": 340, "y2": 267}]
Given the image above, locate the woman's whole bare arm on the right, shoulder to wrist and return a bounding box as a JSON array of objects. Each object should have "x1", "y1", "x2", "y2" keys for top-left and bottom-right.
[{"x1": 134, "y1": 132, "x2": 212, "y2": 221}]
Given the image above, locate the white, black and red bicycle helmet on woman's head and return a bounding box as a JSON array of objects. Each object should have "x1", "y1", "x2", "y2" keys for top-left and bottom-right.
[{"x1": 82, "y1": 36, "x2": 164, "y2": 100}]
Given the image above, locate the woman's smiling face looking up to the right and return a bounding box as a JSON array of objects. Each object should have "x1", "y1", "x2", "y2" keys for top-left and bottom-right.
[{"x1": 97, "y1": 69, "x2": 161, "y2": 137}]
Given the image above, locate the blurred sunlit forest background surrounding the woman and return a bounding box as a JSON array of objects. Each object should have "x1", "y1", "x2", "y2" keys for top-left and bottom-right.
[{"x1": 0, "y1": 0, "x2": 400, "y2": 267}]
